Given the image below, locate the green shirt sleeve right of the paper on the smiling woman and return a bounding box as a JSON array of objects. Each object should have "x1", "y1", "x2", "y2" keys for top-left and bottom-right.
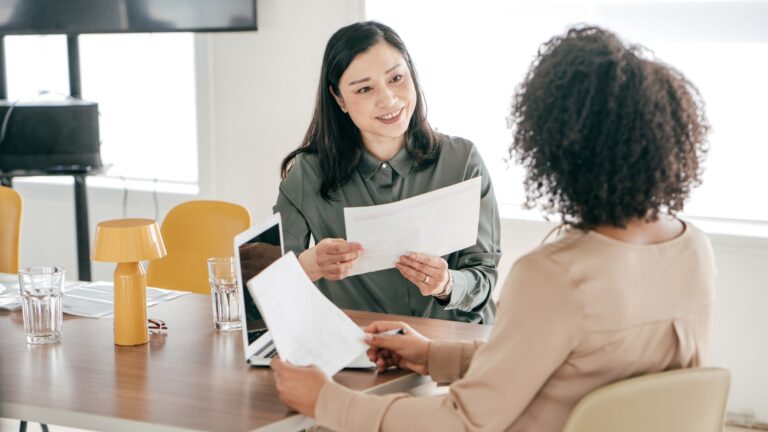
[{"x1": 441, "y1": 145, "x2": 501, "y2": 312}]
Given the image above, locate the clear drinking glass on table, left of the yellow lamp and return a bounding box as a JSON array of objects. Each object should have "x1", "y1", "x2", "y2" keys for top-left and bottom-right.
[{"x1": 19, "y1": 267, "x2": 64, "y2": 345}]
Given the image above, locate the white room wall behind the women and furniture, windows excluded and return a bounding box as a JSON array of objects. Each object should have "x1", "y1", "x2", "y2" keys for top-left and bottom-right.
[{"x1": 12, "y1": 0, "x2": 768, "y2": 422}]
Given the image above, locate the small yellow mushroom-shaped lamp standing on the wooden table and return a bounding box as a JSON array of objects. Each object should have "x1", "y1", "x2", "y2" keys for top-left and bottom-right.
[{"x1": 91, "y1": 219, "x2": 166, "y2": 345}]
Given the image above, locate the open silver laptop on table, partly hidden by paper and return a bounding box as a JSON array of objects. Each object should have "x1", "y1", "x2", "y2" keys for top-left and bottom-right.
[{"x1": 234, "y1": 213, "x2": 376, "y2": 368}]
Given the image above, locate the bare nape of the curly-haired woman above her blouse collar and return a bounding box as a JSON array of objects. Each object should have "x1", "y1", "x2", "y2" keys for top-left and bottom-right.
[{"x1": 594, "y1": 214, "x2": 685, "y2": 245}]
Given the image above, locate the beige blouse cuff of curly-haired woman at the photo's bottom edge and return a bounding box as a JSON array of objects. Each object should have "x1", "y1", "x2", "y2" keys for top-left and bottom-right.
[{"x1": 315, "y1": 381, "x2": 408, "y2": 431}]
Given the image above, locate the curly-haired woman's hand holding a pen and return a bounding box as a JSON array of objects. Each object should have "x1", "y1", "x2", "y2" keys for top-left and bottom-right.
[{"x1": 365, "y1": 321, "x2": 431, "y2": 375}]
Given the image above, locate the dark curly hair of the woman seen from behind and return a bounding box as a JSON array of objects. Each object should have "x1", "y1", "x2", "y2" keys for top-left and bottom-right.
[{"x1": 508, "y1": 27, "x2": 709, "y2": 230}]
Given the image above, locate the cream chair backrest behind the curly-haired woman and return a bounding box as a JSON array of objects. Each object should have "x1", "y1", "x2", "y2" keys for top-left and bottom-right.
[{"x1": 563, "y1": 368, "x2": 731, "y2": 432}]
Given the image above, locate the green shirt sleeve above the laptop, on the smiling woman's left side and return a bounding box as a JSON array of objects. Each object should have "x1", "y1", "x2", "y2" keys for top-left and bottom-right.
[{"x1": 272, "y1": 155, "x2": 310, "y2": 256}]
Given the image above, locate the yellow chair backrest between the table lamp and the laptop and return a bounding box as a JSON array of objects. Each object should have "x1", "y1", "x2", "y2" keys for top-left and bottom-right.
[{"x1": 147, "y1": 200, "x2": 251, "y2": 294}]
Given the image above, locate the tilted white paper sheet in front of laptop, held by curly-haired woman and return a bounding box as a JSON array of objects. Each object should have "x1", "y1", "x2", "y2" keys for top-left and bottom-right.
[{"x1": 246, "y1": 252, "x2": 368, "y2": 377}]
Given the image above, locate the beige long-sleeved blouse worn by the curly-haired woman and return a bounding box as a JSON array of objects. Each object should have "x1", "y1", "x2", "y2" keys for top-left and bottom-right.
[{"x1": 316, "y1": 224, "x2": 715, "y2": 432}]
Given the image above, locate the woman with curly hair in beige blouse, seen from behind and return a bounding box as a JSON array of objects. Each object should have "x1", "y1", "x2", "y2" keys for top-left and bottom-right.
[{"x1": 273, "y1": 27, "x2": 715, "y2": 432}]
